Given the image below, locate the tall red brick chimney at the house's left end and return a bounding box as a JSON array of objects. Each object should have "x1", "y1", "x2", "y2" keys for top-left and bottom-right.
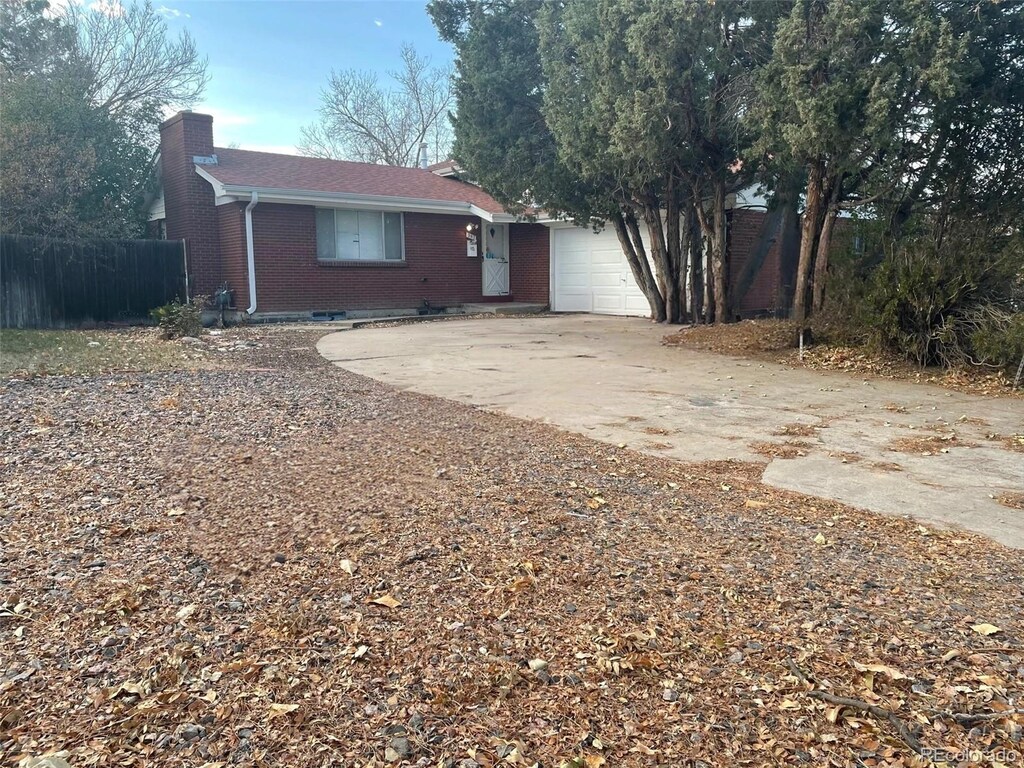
[{"x1": 160, "y1": 111, "x2": 221, "y2": 296}]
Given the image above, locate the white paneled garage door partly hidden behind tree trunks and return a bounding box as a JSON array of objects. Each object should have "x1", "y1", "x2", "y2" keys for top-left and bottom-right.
[{"x1": 551, "y1": 226, "x2": 650, "y2": 317}]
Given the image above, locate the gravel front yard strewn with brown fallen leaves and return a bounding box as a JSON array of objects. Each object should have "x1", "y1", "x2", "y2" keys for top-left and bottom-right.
[{"x1": 0, "y1": 329, "x2": 1024, "y2": 768}]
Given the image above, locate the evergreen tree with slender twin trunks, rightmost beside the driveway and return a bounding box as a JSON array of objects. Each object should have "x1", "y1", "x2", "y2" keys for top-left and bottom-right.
[{"x1": 749, "y1": 0, "x2": 965, "y2": 324}]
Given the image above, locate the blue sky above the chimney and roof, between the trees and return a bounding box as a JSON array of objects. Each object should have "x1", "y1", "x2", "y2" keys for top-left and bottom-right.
[{"x1": 155, "y1": 0, "x2": 453, "y2": 152}]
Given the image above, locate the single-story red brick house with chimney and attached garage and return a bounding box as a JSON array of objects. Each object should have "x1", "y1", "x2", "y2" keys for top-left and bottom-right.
[{"x1": 150, "y1": 112, "x2": 785, "y2": 317}]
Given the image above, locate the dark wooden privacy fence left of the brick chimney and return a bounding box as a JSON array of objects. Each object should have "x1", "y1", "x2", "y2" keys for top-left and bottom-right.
[{"x1": 0, "y1": 234, "x2": 185, "y2": 328}]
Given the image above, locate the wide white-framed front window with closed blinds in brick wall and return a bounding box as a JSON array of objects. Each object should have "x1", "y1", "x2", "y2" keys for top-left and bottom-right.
[{"x1": 316, "y1": 208, "x2": 406, "y2": 261}]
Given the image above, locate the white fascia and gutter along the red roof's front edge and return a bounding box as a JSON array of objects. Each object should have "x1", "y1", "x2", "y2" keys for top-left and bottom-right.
[{"x1": 196, "y1": 166, "x2": 517, "y2": 223}]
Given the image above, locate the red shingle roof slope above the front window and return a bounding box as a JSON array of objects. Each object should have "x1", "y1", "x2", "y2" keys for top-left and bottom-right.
[{"x1": 203, "y1": 146, "x2": 504, "y2": 213}]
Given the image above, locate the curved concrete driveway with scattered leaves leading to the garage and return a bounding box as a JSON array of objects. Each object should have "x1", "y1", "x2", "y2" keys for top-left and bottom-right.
[{"x1": 318, "y1": 315, "x2": 1024, "y2": 548}]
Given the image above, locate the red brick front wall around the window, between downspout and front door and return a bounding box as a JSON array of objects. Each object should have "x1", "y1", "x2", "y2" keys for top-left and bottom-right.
[{"x1": 251, "y1": 203, "x2": 499, "y2": 312}]
